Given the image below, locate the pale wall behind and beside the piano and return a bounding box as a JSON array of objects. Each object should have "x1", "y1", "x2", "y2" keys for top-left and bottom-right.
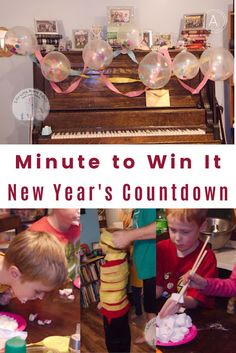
[{"x1": 0, "y1": 0, "x2": 232, "y2": 143}]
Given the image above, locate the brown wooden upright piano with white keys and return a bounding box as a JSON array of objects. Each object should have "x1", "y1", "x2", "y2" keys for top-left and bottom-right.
[{"x1": 32, "y1": 50, "x2": 224, "y2": 144}]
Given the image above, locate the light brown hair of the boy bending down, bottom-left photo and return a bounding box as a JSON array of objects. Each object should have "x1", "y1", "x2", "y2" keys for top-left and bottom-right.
[{"x1": 4, "y1": 231, "x2": 68, "y2": 288}]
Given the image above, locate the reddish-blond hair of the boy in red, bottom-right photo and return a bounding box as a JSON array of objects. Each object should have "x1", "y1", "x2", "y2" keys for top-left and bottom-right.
[{"x1": 165, "y1": 208, "x2": 208, "y2": 226}]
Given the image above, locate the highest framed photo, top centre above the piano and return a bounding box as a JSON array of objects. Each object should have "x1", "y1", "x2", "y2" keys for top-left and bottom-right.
[{"x1": 107, "y1": 6, "x2": 134, "y2": 26}]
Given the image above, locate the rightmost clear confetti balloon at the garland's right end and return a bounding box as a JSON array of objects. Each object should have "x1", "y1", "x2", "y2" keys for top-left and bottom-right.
[{"x1": 200, "y1": 48, "x2": 234, "y2": 81}]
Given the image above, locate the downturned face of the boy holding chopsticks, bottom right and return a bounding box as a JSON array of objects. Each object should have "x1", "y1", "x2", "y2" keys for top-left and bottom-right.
[{"x1": 167, "y1": 216, "x2": 200, "y2": 253}]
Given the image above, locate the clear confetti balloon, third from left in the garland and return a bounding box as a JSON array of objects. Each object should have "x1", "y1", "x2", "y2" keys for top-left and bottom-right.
[{"x1": 82, "y1": 39, "x2": 113, "y2": 70}]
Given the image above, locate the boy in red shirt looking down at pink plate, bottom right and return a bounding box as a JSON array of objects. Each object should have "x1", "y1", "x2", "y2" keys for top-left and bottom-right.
[{"x1": 156, "y1": 209, "x2": 216, "y2": 318}]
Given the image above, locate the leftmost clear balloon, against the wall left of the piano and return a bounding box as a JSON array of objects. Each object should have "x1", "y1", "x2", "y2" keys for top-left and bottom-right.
[{"x1": 4, "y1": 26, "x2": 37, "y2": 55}]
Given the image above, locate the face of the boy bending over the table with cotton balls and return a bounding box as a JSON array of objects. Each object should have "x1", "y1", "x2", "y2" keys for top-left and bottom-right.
[{"x1": 11, "y1": 277, "x2": 54, "y2": 303}]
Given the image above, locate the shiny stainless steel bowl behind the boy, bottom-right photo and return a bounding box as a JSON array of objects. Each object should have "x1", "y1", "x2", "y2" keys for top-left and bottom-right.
[{"x1": 200, "y1": 218, "x2": 235, "y2": 249}]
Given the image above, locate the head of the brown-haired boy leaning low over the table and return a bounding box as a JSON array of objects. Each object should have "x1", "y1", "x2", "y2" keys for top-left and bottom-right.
[{"x1": 0, "y1": 231, "x2": 67, "y2": 305}]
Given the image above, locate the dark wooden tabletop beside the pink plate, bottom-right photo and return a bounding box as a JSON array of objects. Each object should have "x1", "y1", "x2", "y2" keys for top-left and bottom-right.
[{"x1": 159, "y1": 308, "x2": 236, "y2": 353}]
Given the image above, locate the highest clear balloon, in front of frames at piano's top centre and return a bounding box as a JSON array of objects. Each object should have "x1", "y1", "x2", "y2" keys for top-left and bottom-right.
[{"x1": 117, "y1": 23, "x2": 142, "y2": 50}]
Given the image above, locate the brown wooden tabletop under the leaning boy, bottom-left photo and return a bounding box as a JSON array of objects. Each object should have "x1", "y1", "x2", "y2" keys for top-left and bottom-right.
[{"x1": 0, "y1": 284, "x2": 80, "y2": 343}]
